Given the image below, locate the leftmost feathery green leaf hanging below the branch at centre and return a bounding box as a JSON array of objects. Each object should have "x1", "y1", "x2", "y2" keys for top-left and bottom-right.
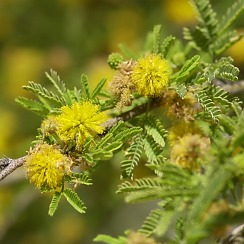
[{"x1": 121, "y1": 137, "x2": 143, "y2": 178}]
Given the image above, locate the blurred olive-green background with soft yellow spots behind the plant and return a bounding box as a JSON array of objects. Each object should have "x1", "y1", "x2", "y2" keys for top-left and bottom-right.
[{"x1": 0, "y1": 0, "x2": 244, "y2": 244}]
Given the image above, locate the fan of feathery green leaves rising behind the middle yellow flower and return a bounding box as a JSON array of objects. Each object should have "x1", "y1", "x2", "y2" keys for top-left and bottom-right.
[{"x1": 16, "y1": 70, "x2": 111, "y2": 117}]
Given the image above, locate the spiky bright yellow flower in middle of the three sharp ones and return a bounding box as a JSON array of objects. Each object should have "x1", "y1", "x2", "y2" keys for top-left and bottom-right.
[{"x1": 56, "y1": 101, "x2": 107, "y2": 148}]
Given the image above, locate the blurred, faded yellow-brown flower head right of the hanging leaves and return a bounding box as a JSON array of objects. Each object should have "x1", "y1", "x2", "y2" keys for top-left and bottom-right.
[{"x1": 170, "y1": 134, "x2": 210, "y2": 171}]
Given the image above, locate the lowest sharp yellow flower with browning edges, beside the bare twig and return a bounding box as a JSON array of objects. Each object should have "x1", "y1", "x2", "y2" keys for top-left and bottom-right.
[{"x1": 24, "y1": 144, "x2": 72, "y2": 190}]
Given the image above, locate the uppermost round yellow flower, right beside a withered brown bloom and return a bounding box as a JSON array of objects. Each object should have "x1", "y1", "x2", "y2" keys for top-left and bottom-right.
[{"x1": 132, "y1": 54, "x2": 171, "y2": 97}]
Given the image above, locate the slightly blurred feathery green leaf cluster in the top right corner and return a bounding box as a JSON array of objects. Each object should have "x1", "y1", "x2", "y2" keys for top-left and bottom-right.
[{"x1": 184, "y1": 0, "x2": 244, "y2": 56}]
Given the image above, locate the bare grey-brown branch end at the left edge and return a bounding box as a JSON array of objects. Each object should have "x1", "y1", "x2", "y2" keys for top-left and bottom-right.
[{"x1": 0, "y1": 157, "x2": 25, "y2": 181}]
